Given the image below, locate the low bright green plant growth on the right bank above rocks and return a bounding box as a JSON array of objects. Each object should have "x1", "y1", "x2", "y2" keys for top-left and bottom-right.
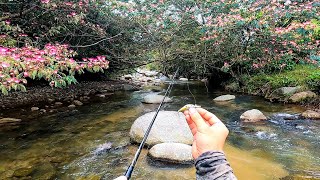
[{"x1": 241, "y1": 65, "x2": 320, "y2": 94}]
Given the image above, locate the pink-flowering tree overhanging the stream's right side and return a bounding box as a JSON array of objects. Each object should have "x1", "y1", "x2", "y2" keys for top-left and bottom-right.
[{"x1": 114, "y1": 0, "x2": 320, "y2": 78}]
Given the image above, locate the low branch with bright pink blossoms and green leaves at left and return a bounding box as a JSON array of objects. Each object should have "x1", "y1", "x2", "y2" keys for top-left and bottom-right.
[{"x1": 0, "y1": 44, "x2": 109, "y2": 95}]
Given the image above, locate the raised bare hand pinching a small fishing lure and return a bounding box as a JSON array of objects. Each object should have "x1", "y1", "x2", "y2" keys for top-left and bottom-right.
[{"x1": 183, "y1": 108, "x2": 229, "y2": 159}]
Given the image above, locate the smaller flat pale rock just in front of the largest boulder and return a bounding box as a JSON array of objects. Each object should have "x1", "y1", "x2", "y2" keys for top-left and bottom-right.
[{"x1": 149, "y1": 143, "x2": 193, "y2": 164}]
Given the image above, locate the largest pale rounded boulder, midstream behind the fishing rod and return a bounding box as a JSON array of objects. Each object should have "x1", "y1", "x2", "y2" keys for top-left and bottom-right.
[{"x1": 130, "y1": 111, "x2": 193, "y2": 145}]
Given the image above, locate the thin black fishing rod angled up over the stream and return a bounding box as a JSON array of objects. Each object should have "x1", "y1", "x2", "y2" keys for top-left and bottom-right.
[{"x1": 124, "y1": 67, "x2": 179, "y2": 179}]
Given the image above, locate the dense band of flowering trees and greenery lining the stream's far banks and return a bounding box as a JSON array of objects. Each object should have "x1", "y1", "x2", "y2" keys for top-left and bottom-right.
[{"x1": 0, "y1": 0, "x2": 320, "y2": 93}]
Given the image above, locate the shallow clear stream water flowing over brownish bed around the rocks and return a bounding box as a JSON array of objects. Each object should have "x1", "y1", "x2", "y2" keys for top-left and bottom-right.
[{"x1": 0, "y1": 83, "x2": 320, "y2": 180}]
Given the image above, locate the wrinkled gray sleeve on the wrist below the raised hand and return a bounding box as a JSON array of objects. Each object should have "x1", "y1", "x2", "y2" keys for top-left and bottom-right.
[{"x1": 195, "y1": 151, "x2": 237, "y2": 180}]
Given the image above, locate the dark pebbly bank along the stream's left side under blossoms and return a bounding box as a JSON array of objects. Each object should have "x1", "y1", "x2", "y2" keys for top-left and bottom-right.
[{"x1": 0, "y1": 80, "x2": 139, "y2": 110}]
